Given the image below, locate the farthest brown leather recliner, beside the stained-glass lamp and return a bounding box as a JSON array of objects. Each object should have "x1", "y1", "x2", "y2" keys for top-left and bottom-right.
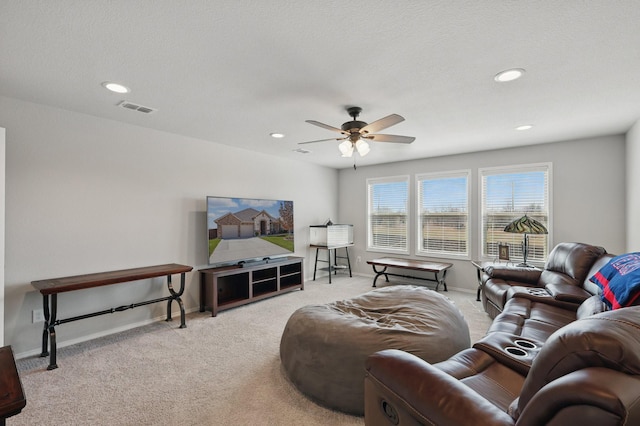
[{"x1": 482, "y1": 243, "x2": 613, "y2": 318}]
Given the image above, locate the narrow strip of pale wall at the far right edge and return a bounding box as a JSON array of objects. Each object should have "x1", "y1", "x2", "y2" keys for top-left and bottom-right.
[{"x1": 626, "y1": 121, "x2": 640, "y2": 252}]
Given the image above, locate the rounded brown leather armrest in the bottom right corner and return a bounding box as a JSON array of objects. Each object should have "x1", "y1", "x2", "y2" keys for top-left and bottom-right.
[{"x1": 518, "y1": 367, "x2": 640, "y2": 426}]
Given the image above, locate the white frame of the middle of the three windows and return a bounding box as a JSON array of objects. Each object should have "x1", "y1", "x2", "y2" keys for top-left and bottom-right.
[{"x1": 414, "y1": 169, "x2": 472, "y2": 260}]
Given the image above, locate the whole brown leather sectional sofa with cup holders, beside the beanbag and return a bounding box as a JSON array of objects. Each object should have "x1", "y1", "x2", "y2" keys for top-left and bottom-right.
[{"x1": 365, "y1": 243, "x2": 640, "y2": 426}]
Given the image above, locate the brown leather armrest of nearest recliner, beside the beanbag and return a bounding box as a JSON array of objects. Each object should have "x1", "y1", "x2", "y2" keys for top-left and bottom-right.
[{"x1": 365, "y1": 349, "x2": 514, "y2": 426}]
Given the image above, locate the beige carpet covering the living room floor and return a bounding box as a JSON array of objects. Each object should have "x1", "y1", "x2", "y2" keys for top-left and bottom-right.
[{"x1": 12, "y1": 275, "x2": 490, "y2": 425}]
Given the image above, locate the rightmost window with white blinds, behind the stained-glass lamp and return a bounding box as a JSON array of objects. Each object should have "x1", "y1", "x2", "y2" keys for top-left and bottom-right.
[{"x1": 479, "y1": 163, "x2": 551, "y2": 263}]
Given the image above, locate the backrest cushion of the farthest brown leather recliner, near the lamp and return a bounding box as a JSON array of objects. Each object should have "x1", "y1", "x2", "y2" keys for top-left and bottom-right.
[{"x1": 540, "y1": 243, "x2": 607, "y2": 286}]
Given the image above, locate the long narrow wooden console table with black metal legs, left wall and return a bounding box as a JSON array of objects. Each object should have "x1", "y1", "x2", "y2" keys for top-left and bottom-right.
[{"x1": 31, "y1": 263, "x2": 193, "y2": 370}]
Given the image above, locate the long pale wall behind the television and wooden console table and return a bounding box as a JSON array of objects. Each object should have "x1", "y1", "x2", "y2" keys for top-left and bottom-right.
[{"x1": 0, "y1": 97, "x2": 338, "y2": 356}]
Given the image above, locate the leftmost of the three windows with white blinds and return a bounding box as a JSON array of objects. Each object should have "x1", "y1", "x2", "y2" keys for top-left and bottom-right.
[{"x1": 367, "y1": 176, "x2": 409, "y2": 253}]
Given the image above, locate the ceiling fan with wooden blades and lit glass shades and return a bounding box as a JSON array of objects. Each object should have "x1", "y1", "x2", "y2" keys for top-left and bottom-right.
[{"x1": 299, "y1": 106, "x2": 416, "y2": 157}]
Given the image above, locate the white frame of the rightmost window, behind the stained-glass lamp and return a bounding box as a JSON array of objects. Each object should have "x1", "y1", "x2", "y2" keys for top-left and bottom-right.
[{"x1": 478, "y1": 162, "x2": 553, "y2": 266}]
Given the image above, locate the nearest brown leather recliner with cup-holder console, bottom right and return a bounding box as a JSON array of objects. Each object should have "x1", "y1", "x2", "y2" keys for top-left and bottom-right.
[{"x1": 365, "y1": 306, "x2": 640, "y2": 426}]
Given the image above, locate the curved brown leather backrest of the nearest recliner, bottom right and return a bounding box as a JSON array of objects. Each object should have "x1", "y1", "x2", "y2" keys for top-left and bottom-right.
[{"x1": 518, "y1": 306, "x2": 640, "y2": 413}]
